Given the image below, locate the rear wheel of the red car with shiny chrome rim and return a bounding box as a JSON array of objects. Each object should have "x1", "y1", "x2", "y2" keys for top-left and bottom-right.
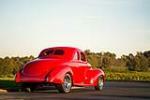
[{"x1": 56, "y1": 73, "x2": 72, "y2": 93}]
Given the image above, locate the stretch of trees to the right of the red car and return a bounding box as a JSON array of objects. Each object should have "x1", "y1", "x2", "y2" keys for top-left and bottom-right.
[{"x1": 85, "y1": 50, "x2": 150, "y2": 71}]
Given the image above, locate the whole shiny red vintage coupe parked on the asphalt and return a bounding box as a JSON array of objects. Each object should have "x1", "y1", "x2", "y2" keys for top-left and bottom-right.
[{"x1": 15, "y1": 47, "x2": 105, "y2": 93}]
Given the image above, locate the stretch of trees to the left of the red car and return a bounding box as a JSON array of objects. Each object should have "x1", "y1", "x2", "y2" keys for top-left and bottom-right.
[{"x1": 0, "y1": 56, "x2": 34, "y2": 77}]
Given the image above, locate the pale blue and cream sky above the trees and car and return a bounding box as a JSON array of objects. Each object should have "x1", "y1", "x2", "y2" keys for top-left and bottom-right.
[{"x1": 0, "y1": 0, "x2": 150, "y2": 57}]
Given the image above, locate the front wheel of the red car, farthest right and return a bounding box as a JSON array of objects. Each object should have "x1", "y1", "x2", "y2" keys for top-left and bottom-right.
[{"x1": 95, "y1": 76, "x2": 104, "y2": 91}]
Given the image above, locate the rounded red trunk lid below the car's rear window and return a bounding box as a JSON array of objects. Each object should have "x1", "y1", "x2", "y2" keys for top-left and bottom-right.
[{"x1": 22, "y1": 59, "x2": 64, "y2": 76}]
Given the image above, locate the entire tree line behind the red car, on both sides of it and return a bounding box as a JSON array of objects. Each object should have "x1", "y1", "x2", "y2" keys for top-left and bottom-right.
[{"x1": 0, "y1": 50, "x2": 150, "y2": 77}]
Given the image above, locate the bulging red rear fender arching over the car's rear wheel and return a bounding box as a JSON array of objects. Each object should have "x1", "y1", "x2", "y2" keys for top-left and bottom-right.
[{"x1": 46, "y1": 66, "x2": 73, "y2": 84}]
